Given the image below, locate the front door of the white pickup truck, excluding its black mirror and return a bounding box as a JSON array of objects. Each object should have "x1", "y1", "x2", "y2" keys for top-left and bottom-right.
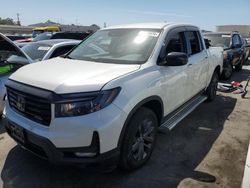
[{"x1": 159, "y1": 28, "x2": 192, "y2": 115}]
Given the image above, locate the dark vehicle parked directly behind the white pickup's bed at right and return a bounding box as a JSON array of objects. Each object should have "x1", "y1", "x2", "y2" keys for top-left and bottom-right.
[{"x1": 203, "y1": 32, "x2": 245, "y2": 79}]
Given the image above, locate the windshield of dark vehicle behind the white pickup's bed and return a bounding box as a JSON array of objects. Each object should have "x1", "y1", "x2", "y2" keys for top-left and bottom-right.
[{"x1": 204, "y1": 34, "x2": 231, "y2": 48}]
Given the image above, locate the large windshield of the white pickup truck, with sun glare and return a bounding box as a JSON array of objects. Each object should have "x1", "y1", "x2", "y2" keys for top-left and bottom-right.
[{"x1": 67, "y1": 29, "x2": 161, "y2": 64}]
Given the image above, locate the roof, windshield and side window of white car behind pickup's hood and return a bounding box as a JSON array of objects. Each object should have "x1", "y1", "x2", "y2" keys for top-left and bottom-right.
[{"x1": 18, "y1": 39, "x2": 81, "y2": 62}]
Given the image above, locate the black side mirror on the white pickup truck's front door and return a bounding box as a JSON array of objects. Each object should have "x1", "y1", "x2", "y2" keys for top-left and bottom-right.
[{"x1": 160, "y1": 52, "x2": 188, "y2": 66}]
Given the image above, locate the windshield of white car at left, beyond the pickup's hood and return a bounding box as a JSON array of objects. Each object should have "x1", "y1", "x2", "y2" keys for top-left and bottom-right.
[{"x1": 22, "y1": 43, "x2": 51, "y2": 62}]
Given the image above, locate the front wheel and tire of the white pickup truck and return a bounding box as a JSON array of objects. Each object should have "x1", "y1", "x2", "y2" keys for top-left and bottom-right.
[{"x1": 119, "y1": 107, "x2": 158, "y2": 170}]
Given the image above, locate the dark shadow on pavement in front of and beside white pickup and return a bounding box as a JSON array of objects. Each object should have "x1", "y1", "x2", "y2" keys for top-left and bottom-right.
[{"x1": 1, "y1": 96, "x2": 236, "y2": 188}]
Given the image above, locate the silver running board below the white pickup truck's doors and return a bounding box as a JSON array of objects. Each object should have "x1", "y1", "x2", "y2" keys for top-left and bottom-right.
[{"x1": 159, "y1": 95, "x2": 207, "y2": 132}]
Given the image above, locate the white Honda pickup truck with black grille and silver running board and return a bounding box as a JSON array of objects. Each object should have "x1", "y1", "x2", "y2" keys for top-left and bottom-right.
[{"x1": 4, "y1": 23, "x2": 223, "y2": 170}]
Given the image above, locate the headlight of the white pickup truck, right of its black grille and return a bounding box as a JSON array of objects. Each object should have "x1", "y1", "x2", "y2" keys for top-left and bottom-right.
[{"x1": 55, "y1": 87, "x2": 121, "y2": 117}]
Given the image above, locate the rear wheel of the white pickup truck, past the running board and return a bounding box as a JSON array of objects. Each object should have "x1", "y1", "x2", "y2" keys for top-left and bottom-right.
[{"x1": 206, "y1": 71, "x2": 219, "y2": 102}]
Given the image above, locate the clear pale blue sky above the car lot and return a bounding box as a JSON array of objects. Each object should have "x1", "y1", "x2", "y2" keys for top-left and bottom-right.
[{"x1": 0, "y1": 0, "x2": 250, "y2": 31}]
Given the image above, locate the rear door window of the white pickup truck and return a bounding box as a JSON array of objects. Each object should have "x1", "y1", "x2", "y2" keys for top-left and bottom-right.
[{"x1": 185, "y1": 31, "x2": 202, "y2": 55}]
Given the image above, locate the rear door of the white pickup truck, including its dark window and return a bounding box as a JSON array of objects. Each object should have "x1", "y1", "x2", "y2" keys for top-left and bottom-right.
[{"x1": 185, "y1": 27, "x2": 209, "y2": 98}]
